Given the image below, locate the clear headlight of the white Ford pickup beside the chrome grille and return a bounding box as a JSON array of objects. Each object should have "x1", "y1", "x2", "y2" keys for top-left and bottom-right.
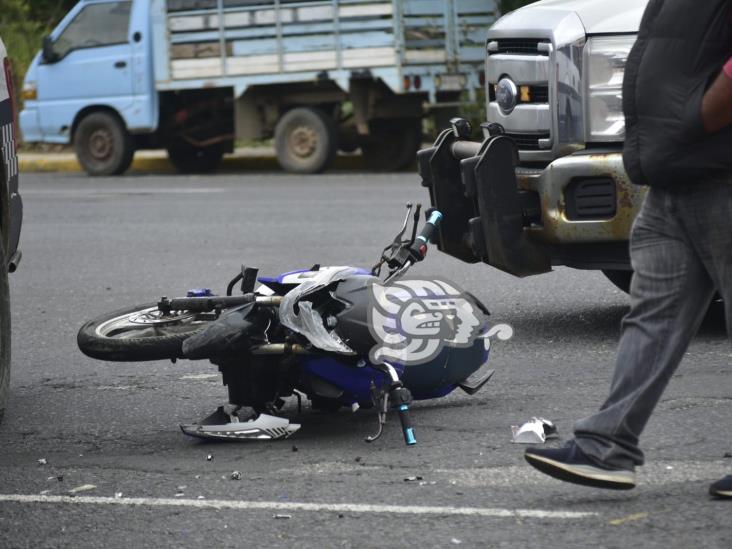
[{"x1": 585, "y1": 35, "x2": 636, "y2": 143}]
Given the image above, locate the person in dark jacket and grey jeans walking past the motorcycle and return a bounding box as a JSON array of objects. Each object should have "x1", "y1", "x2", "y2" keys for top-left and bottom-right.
[{"x1": 525, "y1": 0, "x2": 732, "y2": 498}]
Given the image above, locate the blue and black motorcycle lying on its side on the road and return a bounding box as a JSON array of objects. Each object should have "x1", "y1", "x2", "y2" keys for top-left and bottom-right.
[{"x1": 77, "y1": 204, "x2": 493, "y2": 445}]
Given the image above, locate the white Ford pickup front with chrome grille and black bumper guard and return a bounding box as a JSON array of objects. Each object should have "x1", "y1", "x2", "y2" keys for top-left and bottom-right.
[{"x1": 419, "y1": 0, "x2": 646, "y2": 290}]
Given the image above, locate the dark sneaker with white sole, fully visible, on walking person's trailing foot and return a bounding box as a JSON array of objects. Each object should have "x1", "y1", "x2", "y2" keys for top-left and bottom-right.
[{"x1": 524, "y1": 441, "x2": 635, "y2": 490}]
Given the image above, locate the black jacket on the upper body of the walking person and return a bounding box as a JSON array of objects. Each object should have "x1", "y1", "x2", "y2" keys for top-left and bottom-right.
[{"x1": 623, "y1": 0, "x2": 732, "y2": 187}]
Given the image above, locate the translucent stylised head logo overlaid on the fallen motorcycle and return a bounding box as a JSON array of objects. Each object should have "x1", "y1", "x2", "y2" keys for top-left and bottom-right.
[{"x1": 368, "y1": 279, "x2": 487, "y2": 365}]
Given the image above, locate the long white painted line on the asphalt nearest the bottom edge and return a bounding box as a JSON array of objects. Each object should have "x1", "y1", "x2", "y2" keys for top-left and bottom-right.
[{"x1": 0, "y1": 494, "x2": 598, "y2": 520}]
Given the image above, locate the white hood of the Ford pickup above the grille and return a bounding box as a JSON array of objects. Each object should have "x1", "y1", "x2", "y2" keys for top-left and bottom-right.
[{"x1": 504, "y1": 0, "x2": 648, "y2": 34}]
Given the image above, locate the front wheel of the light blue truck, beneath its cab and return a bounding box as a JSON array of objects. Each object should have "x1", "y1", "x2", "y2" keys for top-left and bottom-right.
[{"x1": 74, "y1": 111, "x2": 135, "y2": 175}]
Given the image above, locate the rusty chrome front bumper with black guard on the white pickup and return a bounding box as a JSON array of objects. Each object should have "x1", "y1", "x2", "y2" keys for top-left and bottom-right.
[{"x1": 417, "y1": 130, "x2": 645, "y2": 276}]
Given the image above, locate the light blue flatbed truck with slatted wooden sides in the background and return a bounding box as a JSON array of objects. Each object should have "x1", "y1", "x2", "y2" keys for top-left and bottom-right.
[{"x1": 20, "y1": 0, "x2": 498, "y2": 175}]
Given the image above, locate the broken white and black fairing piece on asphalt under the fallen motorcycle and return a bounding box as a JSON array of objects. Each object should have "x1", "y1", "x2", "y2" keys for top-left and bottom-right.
[{"x1": 180, "y1": 407, "x2": 300, "y2": 441}]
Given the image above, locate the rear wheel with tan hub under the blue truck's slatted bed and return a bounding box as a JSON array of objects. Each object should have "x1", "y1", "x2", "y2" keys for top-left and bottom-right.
[{"x1": 275, "y1": 107, "x2": 338, "y2": 173}]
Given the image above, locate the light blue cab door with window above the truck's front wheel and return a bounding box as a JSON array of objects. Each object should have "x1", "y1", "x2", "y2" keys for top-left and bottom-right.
[{"x1": 38, "y1": 0, "x2": 134, "y2": 143}]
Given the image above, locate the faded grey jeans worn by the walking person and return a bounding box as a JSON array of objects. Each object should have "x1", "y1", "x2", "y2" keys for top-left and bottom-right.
[{"x1": 574, "y1": 182, "x2": 732, "y2": 469}]
